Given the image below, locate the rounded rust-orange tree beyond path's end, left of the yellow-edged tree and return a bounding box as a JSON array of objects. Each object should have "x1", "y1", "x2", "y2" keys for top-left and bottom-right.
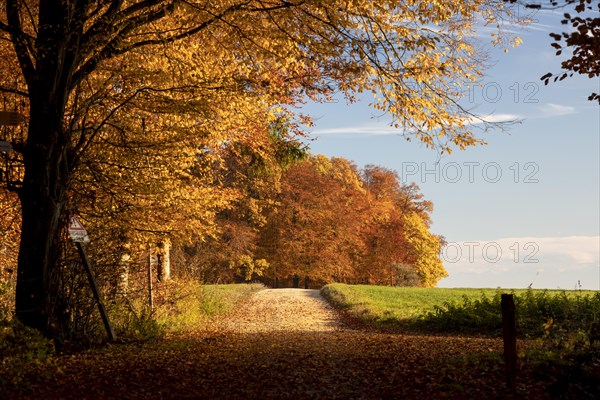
[{"x1": 257, "y1": 155, "x2": 367, "y2": 282}]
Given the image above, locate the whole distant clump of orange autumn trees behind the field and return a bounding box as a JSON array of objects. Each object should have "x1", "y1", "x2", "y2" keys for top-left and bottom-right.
[{"x1": 191, "y1": 148, "x2": 446, "y2": 287}]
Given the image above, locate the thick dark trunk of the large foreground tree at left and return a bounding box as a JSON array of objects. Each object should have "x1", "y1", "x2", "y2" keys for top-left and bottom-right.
[{"x1": 13, "y1": 1, "x2": 77, "y2": 335}]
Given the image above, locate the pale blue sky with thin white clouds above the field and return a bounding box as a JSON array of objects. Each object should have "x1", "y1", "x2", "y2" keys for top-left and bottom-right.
[{"x1": 303, "y1": 4, "x2": 600, "y2": 290}]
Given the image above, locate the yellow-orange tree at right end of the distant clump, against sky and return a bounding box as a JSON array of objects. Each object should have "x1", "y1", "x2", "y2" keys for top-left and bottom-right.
[{"x1": 359, "y1": 165, "x2": 447, "y2": 287}]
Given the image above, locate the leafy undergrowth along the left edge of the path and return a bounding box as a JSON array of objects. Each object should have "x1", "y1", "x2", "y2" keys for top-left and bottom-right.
[{"x1": 0, "y1": 281, "x2": 263, "y2": 358}]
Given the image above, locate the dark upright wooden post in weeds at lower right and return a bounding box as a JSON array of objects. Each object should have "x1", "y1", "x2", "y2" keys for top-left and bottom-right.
[{"x1": 500, "y1": 294, "x2": 517, "y2": 394}]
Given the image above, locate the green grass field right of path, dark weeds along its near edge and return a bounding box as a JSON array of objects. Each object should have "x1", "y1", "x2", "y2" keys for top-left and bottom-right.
[{"x1": 322, "y1": 284, "x2": 600, "y2": 334}]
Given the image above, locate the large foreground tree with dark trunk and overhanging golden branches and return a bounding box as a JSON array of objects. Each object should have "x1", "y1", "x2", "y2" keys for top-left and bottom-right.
[{"x1": 0, "y1": 0, "x2": 516, "y2": 331}]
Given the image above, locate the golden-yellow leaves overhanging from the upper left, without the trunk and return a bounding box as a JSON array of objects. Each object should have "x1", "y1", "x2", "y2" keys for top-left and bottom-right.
[{"x1": 0, "y1": 0, "x2": 516, "y2": 282}]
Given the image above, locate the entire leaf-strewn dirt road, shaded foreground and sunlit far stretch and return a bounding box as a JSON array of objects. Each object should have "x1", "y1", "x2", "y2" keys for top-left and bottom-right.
[{"x1": 0, "y1": 289, "x2": 540, "y2": 400}]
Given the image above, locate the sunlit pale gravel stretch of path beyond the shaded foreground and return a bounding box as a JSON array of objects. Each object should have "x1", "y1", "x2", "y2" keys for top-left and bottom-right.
[{"x1": 220, "y1": 289, "x2": 344, "y2": 333}]
